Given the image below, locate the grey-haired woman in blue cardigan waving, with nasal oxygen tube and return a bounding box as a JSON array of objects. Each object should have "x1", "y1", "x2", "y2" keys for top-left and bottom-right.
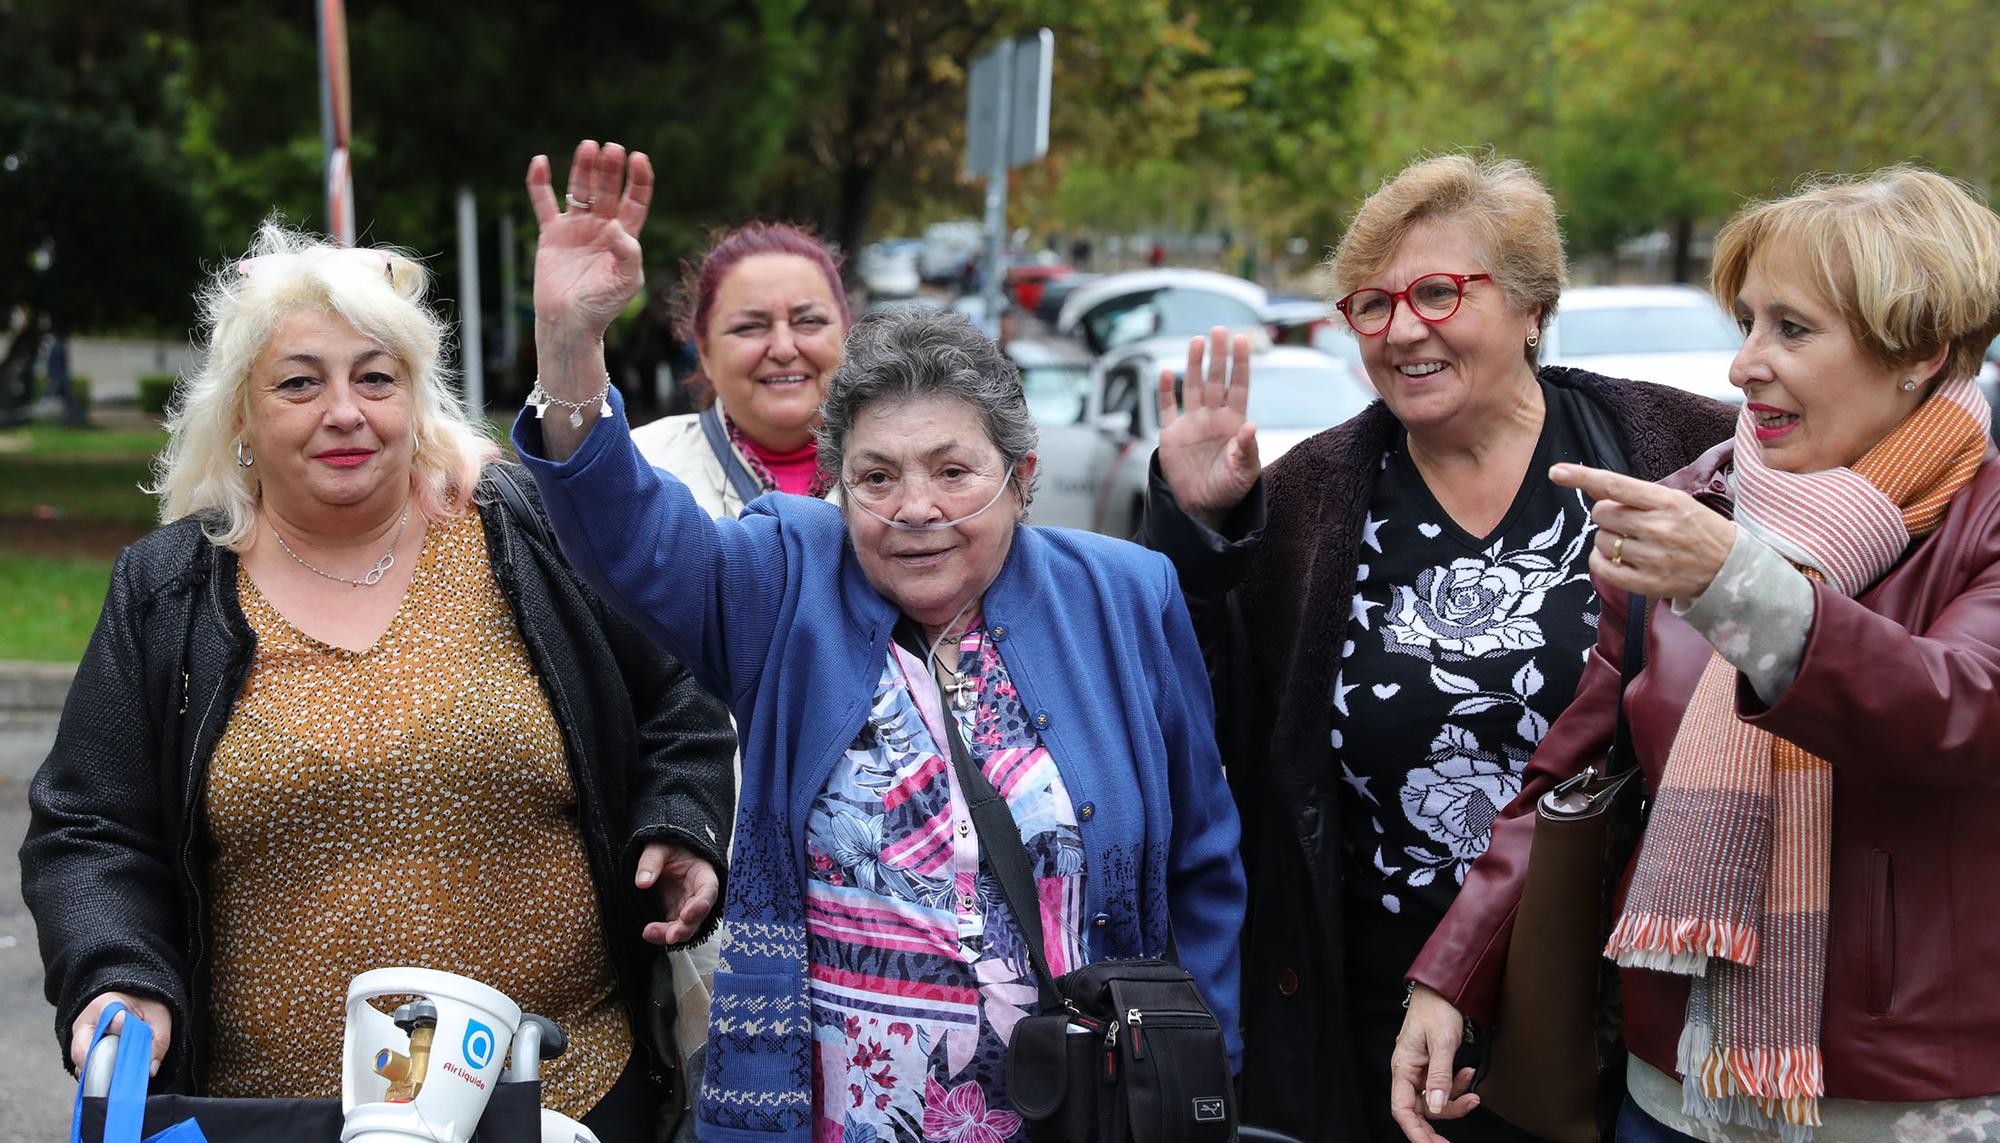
[{"x1": 514, "y1": 142, "x2": 1244, "y2": 1143}]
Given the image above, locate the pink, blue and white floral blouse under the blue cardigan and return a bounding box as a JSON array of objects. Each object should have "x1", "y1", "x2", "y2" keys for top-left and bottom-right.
[{"x1": 806, "y1": 623, "x2": 1084, "y2": 1143}]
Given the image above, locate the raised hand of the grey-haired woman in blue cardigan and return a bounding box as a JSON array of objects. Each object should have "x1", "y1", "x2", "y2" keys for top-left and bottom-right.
[{"x1": 528, "y1": 140, "x2": 652, "y2": 342}]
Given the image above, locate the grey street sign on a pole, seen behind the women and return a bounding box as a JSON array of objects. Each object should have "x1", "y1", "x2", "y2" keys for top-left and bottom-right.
[{"x1": 966, "y1": 28, "x2": 1056, "y2": 336}]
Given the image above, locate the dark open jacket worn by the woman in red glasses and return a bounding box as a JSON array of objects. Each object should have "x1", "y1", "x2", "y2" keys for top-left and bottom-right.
[{"x1": 1140, "y1": 368, "x2": 1734, "y2": 1139}]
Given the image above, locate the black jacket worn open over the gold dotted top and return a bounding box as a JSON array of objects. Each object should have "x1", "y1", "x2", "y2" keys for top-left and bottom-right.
[{"x1": 20, "y1": 468, "x2": 736, "y2": 1091}]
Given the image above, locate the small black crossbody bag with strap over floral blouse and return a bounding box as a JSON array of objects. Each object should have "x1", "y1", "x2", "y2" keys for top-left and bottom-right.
[{"x1": 896, "y1": 623, "x2": 1236, "y2": 1143}]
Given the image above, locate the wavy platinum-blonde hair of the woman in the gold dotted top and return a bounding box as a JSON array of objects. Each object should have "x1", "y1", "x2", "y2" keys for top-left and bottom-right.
[{"x1": 148, "y1": 218, "x2": 500, "y2": 552}]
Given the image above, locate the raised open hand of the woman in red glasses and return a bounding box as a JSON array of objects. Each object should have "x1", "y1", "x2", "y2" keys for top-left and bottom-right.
[{"x1": 1160, "y1": 326, "x2": 1264, "y2": 528}]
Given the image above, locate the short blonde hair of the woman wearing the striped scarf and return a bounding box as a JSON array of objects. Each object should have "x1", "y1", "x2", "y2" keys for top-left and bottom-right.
[{"x1": 1710, "y1": 164, "x2": 2000, "y2": 382}]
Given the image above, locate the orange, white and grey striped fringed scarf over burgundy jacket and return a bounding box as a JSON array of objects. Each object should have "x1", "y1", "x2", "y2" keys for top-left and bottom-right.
[{"x1": 1606, "y1": 380, "x2": 1990, "y2": 1143}]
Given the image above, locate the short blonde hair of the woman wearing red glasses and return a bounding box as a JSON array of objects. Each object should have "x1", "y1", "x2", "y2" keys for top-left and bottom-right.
[{"x1": 1326, "y1": 154, "x2": 1570, "y2": 366}]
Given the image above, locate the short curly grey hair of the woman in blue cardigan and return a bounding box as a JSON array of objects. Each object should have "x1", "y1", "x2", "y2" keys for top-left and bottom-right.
[{"x1": 814, "y1": 306, "x2": 1040, "y2": 506}]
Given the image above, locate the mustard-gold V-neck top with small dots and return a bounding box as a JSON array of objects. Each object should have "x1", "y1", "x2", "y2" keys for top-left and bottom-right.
[{"x1": 206, "y1": 512, "x2": 632, "y2": 1115}]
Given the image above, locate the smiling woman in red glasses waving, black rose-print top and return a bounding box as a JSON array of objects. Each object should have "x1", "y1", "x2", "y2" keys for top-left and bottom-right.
[{"x1": 1146, "y1": 156, "x2": 1732, "y2": 1143}]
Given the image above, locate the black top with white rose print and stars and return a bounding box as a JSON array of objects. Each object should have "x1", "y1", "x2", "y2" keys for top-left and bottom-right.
[{"x1": 1332, "y1": 386, "x2": 1598, "y2": 931}]
